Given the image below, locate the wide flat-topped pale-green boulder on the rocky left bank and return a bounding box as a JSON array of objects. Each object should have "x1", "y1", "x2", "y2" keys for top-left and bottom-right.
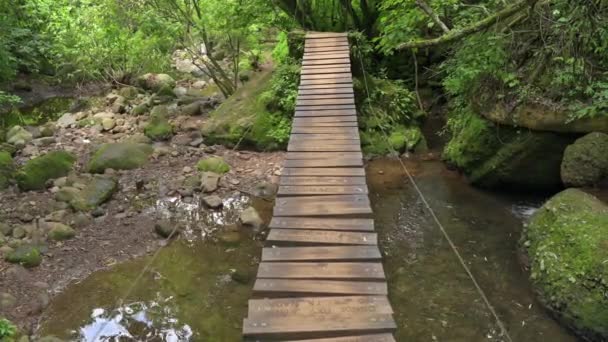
[{"x1": 87, "y1": 142, "x2": 154, "y2": 173}]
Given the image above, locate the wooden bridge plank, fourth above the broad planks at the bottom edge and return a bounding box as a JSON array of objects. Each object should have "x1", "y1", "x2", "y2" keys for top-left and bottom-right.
[{"x1": 266, "y1": 229, "x2": 378, "y2": 246}]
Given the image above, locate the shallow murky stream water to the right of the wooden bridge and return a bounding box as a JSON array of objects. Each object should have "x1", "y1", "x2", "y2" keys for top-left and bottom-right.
[{"x1": 367, "y1": 160, "x2": 576, "y2": 342}]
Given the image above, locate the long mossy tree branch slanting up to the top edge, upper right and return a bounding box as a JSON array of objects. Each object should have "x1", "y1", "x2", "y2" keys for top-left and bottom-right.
[{"x1": 397, "y1": 0, "x2": 534, "y2": 50}]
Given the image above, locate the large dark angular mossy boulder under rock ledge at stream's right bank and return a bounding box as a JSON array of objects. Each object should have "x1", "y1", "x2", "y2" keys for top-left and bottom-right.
[{"x1": 443, "y1": 113, "x2": 575, "y2": 190}]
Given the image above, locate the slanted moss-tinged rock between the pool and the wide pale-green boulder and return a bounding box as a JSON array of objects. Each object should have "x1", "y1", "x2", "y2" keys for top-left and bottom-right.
[{"x1": 70, "y1": 176, "x2": 118, "y2": 211}]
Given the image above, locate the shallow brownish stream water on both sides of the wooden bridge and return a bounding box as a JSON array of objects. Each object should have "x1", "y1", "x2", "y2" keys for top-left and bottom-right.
[{"x1": 41, "y1": 160, "x2": 576, "y2": 342}]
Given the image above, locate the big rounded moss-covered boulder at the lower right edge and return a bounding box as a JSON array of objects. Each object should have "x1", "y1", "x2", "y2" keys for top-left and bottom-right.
[{"x1": 522, "y1": 189, "x2": 608, "y2": 341}]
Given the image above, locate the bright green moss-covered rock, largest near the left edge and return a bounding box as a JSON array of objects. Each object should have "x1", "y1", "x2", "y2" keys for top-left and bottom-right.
[{"x1": 15, "y1": 151, "x2": 76, "y2": 191}]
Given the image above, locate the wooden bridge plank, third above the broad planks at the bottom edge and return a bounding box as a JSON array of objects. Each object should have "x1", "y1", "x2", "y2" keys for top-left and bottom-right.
[{"x1": 262, "y1": 246, "x2": 382, "y2": 261}]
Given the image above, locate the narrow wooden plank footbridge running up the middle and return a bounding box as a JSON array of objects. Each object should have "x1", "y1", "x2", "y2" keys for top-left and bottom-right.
[{"x1": 243, "y1": 33, "x2": 396, "y2": 342}]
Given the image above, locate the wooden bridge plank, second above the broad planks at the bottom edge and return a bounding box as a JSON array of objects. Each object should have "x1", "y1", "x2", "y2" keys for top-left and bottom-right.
[{"x1": 258, "y1": 262, "x2": 385, "y2": 280}]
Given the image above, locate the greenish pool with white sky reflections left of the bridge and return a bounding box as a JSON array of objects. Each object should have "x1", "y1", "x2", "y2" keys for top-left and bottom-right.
[{"x1": 41, "y1": 196, "x2": 271, "y2": 342}]
